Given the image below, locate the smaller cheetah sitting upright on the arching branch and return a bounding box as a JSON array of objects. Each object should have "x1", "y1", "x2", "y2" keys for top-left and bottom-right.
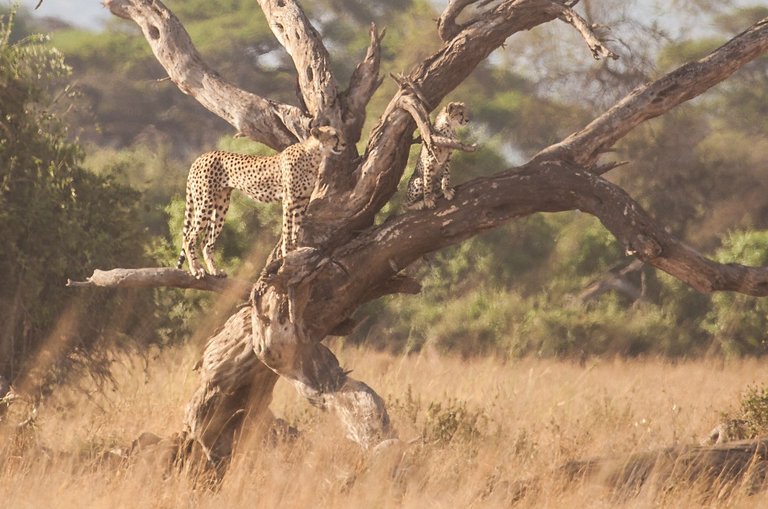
[{"x1": 405, "y1": 102, "x2": 469, "y2": 210}]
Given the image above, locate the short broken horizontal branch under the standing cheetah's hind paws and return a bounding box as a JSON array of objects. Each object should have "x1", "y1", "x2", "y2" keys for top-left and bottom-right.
[{"x1": 67, "y1": 267, "x2": 253, "y2": 298}]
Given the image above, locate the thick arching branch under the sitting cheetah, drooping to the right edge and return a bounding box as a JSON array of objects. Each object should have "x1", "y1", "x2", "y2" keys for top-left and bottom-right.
[{"x1": 344, "y1": 161, "x2": 768, "y2": 296}]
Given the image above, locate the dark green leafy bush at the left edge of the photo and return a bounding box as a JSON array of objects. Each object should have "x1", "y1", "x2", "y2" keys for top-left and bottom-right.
[{"x1": 0, "y1": 9, "x2": 158, "y2": 381}]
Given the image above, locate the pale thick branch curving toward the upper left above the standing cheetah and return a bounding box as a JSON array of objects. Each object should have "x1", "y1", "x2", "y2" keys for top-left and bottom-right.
[{"x1": 104, "y1": 0, "x2": 310, "y2": 149}]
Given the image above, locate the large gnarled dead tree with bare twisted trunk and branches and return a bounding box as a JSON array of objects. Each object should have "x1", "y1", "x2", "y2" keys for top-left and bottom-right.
[{"x1": 70, "y1": 0, "x2": 768, "y2": 468}]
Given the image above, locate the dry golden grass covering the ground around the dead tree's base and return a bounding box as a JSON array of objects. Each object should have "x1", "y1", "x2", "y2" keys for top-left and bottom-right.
[{"x1": 0, "y1": 348, "x2": 765, "y2": 508}]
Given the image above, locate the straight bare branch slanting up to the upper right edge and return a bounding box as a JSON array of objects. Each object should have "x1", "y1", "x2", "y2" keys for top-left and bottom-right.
[{"x1": 536, "y1": 18, "x2": 768, "y2": 166}]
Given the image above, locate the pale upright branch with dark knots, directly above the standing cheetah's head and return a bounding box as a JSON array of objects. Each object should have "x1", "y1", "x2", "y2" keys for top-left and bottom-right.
[{"x1": 259, "y1": 0, "x2": 342, "y2": 129}]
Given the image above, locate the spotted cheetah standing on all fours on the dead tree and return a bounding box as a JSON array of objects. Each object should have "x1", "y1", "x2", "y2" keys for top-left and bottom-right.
[{"x1": 176, "y1": 126, "x2": 347, "y2": 279}]
